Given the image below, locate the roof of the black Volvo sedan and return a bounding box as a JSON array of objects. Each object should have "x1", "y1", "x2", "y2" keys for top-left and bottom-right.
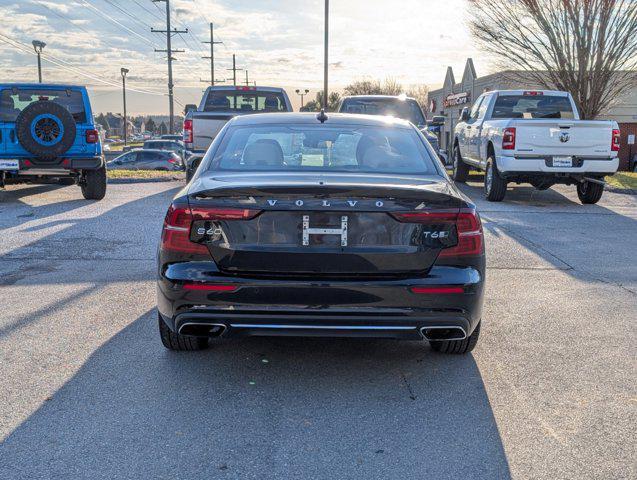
[{"x1": 228, "y1": 112, "x2": 411, "y2": 128}]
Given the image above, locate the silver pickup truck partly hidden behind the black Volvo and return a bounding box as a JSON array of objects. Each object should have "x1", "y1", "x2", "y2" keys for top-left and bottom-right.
[{"x1": 184, "y1": 86, "x2": 292, "y2": 153}]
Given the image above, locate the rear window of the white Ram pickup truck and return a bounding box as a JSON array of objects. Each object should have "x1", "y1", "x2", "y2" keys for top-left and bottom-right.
[{"x1": 491, "y1": 95, "x2": 574, "y2": 118}]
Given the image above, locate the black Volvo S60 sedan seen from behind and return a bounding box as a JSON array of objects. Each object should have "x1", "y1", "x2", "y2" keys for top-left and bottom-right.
[{"x1": 158, "y1": 113, "x2": 485, "y2": 353}]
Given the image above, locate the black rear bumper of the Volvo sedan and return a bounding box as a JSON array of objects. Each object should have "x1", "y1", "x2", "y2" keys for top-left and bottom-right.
[{"x1": 158, "y1": 262, "x2": 484, "y2": 339}]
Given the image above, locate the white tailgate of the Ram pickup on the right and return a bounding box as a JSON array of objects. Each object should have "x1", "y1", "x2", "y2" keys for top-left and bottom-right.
[{"x1": 512, "y1": 120, "x2": 613, "y2": 157}]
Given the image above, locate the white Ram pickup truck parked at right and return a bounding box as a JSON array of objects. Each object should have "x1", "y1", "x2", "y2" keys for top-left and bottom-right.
[{"x1": 453, "y1": 90, "x2": 620, "y2": 203}]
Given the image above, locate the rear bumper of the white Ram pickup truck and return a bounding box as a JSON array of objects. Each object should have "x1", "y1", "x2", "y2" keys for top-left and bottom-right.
[{"x1": 496, "y1": 156, "x2": 619, "y2": 175}]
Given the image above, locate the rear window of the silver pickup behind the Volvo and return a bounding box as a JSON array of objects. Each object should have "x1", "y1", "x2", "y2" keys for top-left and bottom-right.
[{"x1": 203, "y1": 90, "x2": 287, "y2": 113}]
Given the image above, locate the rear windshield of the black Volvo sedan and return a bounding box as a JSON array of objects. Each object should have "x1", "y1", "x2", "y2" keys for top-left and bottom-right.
[{"x1": 209, "y1": 125, "x2": 438, "y2": 175}]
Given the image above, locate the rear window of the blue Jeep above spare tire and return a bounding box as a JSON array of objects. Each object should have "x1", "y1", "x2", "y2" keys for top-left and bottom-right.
[{"x1": 0, "y1": 88, "x2": 86, "y2": 123}]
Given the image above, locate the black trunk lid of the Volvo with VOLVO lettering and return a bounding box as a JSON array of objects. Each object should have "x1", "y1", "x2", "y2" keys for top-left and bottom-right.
[{"x1": 189, "y1": 173, "x2": 464, "y2": 277}]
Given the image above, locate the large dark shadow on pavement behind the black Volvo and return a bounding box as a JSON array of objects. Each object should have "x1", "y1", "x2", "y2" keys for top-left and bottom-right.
[{"x1": 0, "y1": 310, "x2": 510, "y2": 479}]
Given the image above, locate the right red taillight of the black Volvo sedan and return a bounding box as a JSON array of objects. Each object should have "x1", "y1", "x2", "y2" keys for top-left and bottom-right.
[{"x1": 392, "y1": 208, "x2": 482, "y2": 257}]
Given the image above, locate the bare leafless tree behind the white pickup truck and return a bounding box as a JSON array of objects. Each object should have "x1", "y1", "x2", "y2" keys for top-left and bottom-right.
[{"x1": 470, "y1": 0, "x2": 637, "y2": 119}]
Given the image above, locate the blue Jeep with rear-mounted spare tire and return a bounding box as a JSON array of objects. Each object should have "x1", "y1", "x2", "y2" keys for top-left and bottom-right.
[{"x1": 0, "y1": 83, "x2": 106, "y2": 200}]
